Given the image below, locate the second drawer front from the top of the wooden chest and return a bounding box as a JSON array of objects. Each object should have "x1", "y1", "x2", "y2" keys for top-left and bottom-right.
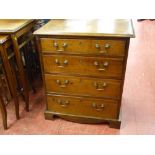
[{"x1": 43, "y1": 55, "x2": 123, "y2": 78}]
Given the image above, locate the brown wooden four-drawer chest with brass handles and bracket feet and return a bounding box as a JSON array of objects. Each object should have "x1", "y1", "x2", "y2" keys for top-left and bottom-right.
[{"x1": 34, "y1": 20, "x2": 134, "y2": 128}]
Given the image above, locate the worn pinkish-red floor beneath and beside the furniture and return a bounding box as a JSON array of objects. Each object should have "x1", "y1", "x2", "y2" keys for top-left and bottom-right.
[{"x1": 0, "y1": 20, "x2": 155, "y2": 135}]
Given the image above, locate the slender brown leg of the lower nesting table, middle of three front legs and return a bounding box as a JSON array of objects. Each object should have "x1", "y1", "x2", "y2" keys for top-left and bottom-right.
[{"x1": 1, "y1": 45, "x2": 19, "y2": 119}]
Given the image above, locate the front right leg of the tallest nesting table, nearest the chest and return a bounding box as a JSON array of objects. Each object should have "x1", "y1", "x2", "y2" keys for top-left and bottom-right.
[{"x1": 11, "y1": 35, "x2": 29, "y2": 111}]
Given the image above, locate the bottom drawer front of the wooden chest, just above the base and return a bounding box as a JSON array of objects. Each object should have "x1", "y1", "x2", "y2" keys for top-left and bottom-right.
[{"x1": 47, "y1": 95, "x2": 118, "y2": 119}]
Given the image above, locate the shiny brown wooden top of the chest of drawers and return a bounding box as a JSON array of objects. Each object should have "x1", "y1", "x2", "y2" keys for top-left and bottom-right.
[{"x1": 34, "y1": 19, "x2": 135, "y2": 37}]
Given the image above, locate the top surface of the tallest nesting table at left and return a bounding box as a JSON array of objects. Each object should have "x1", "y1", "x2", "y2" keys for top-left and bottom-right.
[{"x1": 0, "y1": 19, "x2": 33, "y2": 33}]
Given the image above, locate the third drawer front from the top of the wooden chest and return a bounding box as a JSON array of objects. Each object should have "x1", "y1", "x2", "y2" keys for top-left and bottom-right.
[{"x1": 45, "y1": 74, "x2": 120, "y2": 99}]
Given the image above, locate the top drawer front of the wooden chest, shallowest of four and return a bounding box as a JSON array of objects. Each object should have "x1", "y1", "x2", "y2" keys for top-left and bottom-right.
[{"x1": 41, "y1": 38, "x2": 125, "y2": 56}]
